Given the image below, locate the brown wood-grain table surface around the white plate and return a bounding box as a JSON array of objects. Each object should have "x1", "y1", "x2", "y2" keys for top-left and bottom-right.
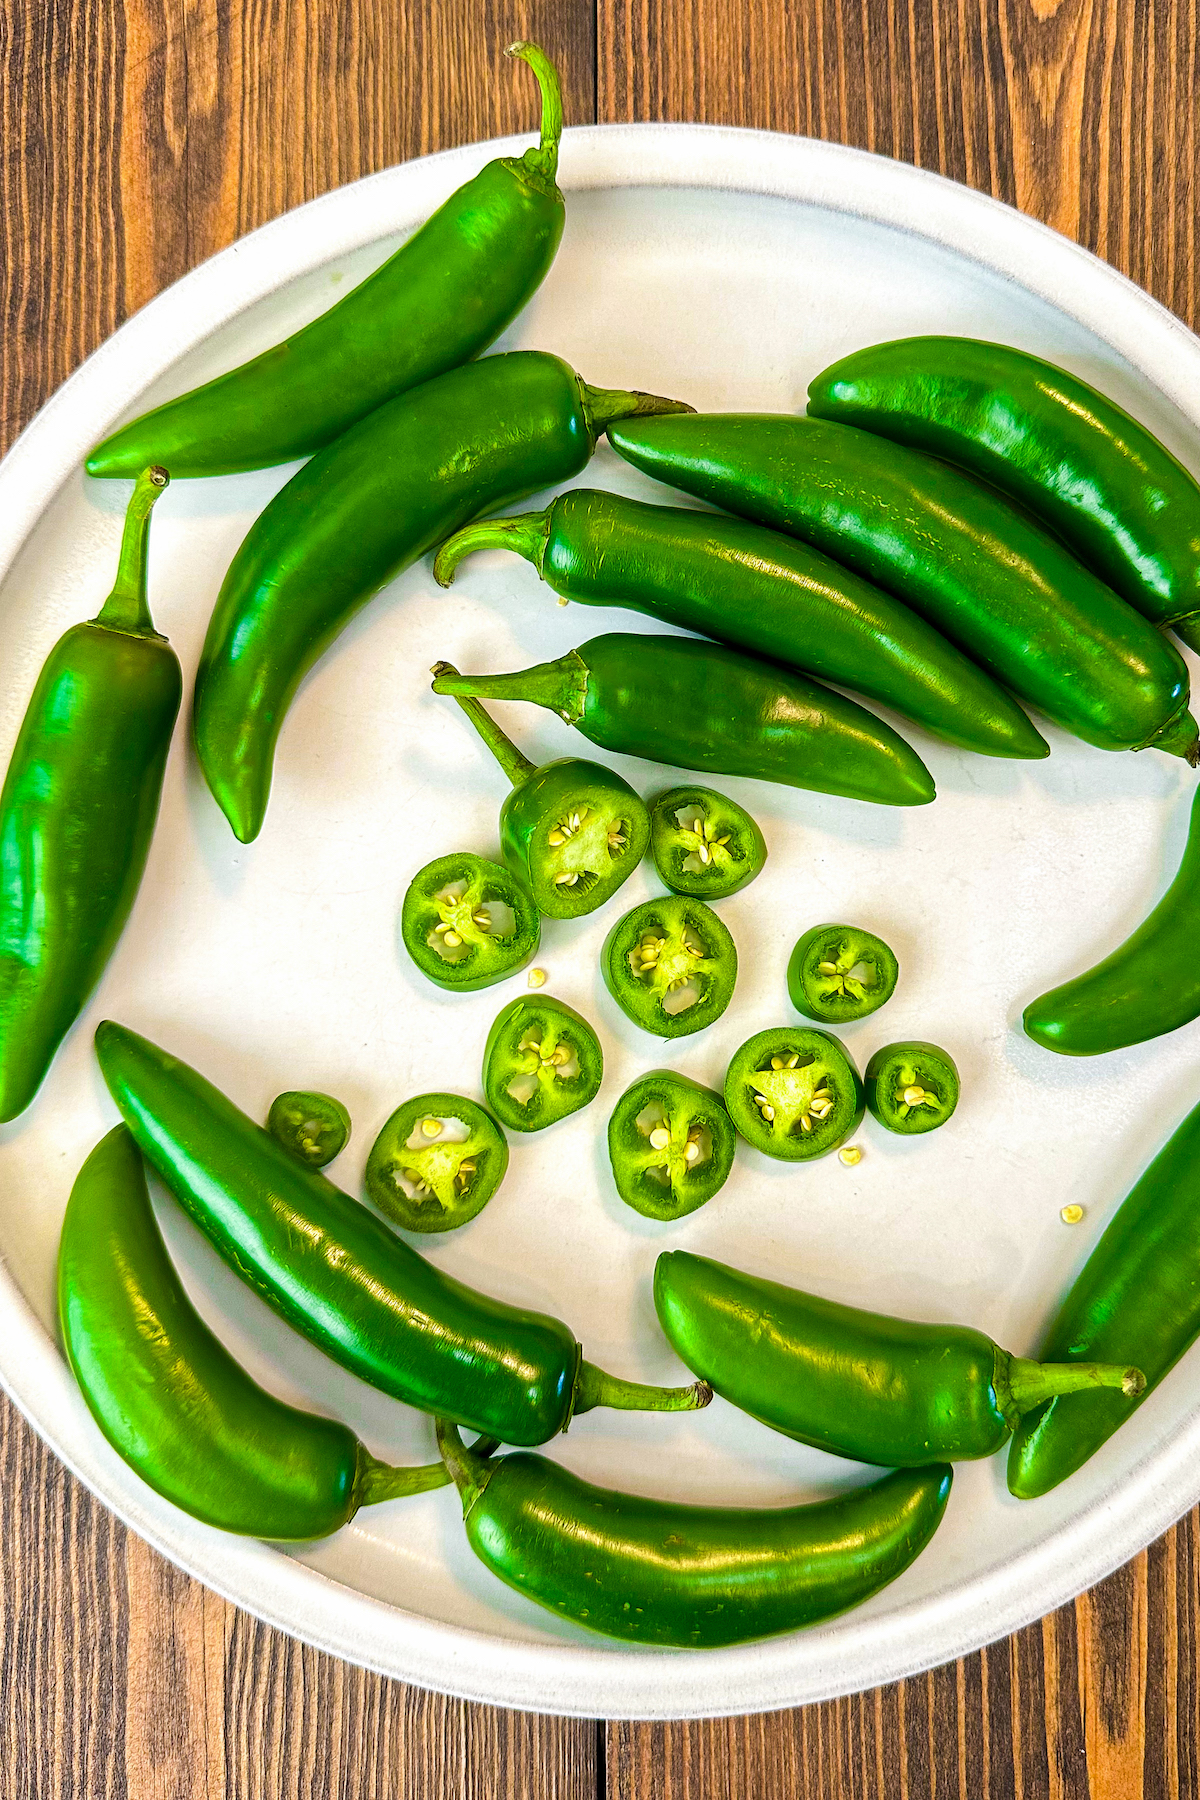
[{"x1": 0, "y1": 0, "x2": 1200, "y2": 1800}]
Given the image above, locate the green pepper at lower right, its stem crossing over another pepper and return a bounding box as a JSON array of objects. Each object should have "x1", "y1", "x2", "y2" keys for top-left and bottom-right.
[{"x1": 655, "y1": 1249, "x2": 1142, "y2": 1469}]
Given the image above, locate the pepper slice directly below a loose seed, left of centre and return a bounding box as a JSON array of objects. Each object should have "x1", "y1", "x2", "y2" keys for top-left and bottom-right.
[{"x1": 484, "y1": 994, "x2": 604, "y2": 1130}]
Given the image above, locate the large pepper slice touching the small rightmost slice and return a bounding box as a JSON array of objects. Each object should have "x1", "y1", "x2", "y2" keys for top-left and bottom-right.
[{"x1": 725, "y1": 1024, "x2": 865, "y2": 1163}]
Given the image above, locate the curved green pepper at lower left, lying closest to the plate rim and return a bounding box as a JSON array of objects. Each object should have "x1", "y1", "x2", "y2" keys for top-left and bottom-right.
[{"x1": 58, "y1": 1125, "x2": 446, "y2": 1541}]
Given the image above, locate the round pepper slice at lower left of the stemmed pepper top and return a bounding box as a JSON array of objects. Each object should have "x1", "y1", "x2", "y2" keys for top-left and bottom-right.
[{"x1": 399, "y1": 850, "x2": 542, "y2": 994}]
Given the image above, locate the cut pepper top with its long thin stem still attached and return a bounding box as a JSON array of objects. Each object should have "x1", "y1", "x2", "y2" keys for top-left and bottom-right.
[{"x1": 432, "y1": 662, "x2": 649, "y2": 918}]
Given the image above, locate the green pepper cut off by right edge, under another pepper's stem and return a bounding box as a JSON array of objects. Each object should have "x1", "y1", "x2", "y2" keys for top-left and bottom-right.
[{"x1": 1007, "y1": 1107, "x2": 1200, "y2": 1499}]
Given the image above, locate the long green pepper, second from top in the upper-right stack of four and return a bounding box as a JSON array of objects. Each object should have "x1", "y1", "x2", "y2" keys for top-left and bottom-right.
[{"x1": 610, "y1": 414, "x2": 1196, "y2": 761}]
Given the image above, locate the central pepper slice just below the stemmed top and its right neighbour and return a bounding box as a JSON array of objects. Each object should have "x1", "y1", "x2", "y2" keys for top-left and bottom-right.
[{"x1": 601, "y1": 895, "x2": 738, "y2": 1037}]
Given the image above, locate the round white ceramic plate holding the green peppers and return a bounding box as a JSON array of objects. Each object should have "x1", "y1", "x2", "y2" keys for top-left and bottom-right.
[{"x1": 0, "y1": 126, "x2": 1200, "y2": 1717}]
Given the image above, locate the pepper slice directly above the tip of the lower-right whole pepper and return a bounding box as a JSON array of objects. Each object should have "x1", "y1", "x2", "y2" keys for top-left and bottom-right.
[{"x1": 608, "y1": 1069, "x2": 736, "y2": 1219}]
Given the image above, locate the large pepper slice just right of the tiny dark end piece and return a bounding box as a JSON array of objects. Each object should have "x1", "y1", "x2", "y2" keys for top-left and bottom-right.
[{"x1": 363, "y1": 1094, "x2": 509, "y2": 1231}]
